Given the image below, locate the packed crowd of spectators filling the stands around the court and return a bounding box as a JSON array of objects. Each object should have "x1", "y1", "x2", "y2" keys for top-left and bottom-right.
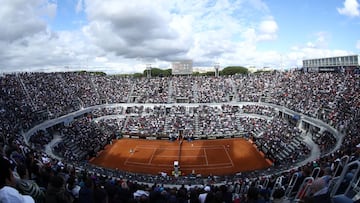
[{"x1": 0, "y1": 72, "x2": 360, "y2": 202}]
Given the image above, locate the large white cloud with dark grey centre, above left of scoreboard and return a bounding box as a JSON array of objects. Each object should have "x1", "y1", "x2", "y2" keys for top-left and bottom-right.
[{"x1": 85, "y1": 0, "x2": 191, "y2": 60}]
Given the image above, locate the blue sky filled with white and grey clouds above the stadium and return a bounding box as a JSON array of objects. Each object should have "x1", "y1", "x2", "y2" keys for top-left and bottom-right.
[{"x1": 0, "y1": 0, "x2": 360, "y2": 73}]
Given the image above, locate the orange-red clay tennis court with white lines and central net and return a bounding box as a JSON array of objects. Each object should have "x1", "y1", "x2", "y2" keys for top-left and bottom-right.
[{"x1": 91, "y1": 138, "x2": 271, "y2": 175}]
